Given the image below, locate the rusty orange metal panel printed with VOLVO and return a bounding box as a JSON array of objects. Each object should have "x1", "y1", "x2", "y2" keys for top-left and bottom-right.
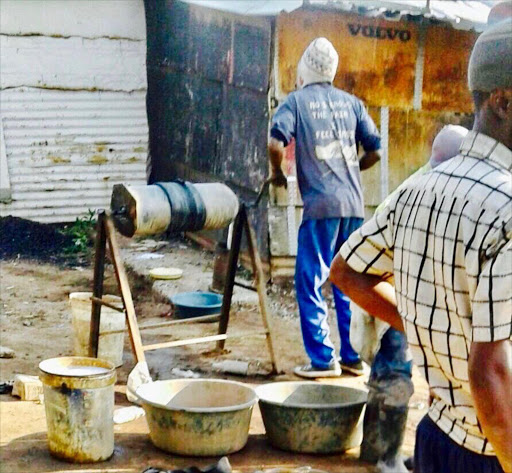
[{"x1": 277, "y1": 10, "x2": 418, "y2": 108}]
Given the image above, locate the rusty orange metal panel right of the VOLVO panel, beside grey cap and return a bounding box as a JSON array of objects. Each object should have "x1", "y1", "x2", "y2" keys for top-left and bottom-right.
[{"x1": 423, "y1": 25, "x2": 478, "y2": 113}]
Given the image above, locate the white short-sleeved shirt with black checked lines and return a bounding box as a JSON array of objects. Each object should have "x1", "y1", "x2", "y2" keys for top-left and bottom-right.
[{"x1": 340, "y1": 132, "x2": 512, "y2": 455}]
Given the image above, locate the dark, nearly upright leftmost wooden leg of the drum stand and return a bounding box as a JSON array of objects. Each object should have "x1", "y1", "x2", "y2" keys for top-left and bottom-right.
[{"x1": 89, "y1": 210, "x2": 107, "y2": 358}]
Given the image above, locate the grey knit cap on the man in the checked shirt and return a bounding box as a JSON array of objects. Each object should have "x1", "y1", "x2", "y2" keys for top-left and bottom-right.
[{"x1": 468, "y1": 17, "x2": 512, "y2": 92}]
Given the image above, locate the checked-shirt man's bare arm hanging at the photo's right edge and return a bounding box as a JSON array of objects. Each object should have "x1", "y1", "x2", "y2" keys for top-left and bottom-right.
[{"x1": 469, "y1": 340, "x2": 512, "y2": 473}]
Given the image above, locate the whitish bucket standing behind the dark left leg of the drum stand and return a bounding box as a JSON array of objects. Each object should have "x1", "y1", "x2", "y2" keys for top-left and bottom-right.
[{"x1": 69, "y1": 292, "x2": 126, "y2": 368}]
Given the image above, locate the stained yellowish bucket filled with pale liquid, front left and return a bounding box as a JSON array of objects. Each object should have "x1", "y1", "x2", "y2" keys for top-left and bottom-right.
[{"x1": 39, "y1": 356, "x2": 116, "y2": 463}]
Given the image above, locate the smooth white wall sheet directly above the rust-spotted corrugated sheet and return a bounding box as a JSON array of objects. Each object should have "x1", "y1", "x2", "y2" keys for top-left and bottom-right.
[{"x1": 0, "y1": 35, "x2": 147, "y2": 92}]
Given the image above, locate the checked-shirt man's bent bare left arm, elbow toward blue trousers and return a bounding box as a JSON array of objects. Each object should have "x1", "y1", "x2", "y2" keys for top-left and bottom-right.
[{"x1": 330, "y1": 254, "x2": 404, "y2": 332}]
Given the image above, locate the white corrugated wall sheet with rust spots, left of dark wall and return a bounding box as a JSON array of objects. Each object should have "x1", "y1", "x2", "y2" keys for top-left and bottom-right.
[{"x1": 0, "y1": 88, "x2": 148, "y2": 222}]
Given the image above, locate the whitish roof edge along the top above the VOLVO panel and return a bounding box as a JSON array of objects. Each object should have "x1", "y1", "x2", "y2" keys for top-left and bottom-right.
[{"x1": 182, "y1": 0, "x2": 499, "y2": 31}]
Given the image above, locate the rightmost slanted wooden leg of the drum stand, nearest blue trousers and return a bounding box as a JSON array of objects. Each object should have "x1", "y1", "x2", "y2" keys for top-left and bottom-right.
[{"x1": 243, "y1": 209, "x2": 279, "y2": 373}]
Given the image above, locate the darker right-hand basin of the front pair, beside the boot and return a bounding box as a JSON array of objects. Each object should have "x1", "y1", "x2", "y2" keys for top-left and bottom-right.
[{"x1": 256, "y1": 382, "x2": 367, "y2": 453}]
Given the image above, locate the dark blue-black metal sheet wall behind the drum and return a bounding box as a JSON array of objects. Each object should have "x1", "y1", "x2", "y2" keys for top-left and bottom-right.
[{"x1": 145, "y1": 0, "x2": 271, "y2": 259}]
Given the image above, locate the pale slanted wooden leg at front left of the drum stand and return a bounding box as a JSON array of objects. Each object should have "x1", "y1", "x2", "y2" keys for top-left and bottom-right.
[{"x1": 105, "y1": 217, "x2": 146, "y2": 363}]
